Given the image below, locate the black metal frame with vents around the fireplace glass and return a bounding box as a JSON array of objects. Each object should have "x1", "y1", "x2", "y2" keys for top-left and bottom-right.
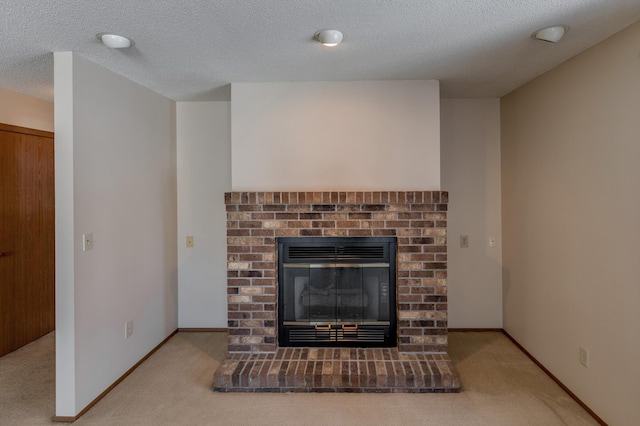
[{"x1": 277, "y1": 237, "x2": 397, "y2": 347}]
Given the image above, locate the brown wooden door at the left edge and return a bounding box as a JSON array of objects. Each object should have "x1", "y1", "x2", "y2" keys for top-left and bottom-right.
[{"x1": 0, "y1": 124, "x2": 55, "y2": 356}]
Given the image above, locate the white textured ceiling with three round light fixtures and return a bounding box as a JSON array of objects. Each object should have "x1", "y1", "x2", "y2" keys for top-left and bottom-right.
[{"x1": 0, "y1": 0, "x2": 640, "y2": 101}]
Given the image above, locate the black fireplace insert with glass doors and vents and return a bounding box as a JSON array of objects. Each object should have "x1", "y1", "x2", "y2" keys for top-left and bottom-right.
[{"x1": 278, "y1": 237, "x2": 397, "y2": 347}]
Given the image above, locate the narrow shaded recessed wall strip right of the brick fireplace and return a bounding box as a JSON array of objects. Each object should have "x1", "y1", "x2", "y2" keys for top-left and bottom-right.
[{"x1": 440, "y1": 99, "x2": 502, "y2": 328}]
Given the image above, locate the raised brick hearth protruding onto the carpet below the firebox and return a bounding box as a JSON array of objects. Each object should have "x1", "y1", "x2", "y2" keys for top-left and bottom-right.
[{"x1": 213, "y1": 348, "x2": 460, "y2": 393}]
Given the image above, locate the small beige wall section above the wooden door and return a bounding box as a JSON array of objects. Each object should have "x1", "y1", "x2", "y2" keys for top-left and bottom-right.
[{"x1": 0, "y1": 88, "x2": 54, "y2": 132}]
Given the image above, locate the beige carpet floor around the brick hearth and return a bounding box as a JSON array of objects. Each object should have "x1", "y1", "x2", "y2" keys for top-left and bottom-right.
[{"x1": 0, "y1": 332, "x2": 597, "y2": 426}]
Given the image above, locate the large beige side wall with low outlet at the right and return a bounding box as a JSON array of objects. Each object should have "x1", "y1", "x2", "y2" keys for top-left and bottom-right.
[{"x1": 501, "y1": 23, "x2": 640, "y2": 425}]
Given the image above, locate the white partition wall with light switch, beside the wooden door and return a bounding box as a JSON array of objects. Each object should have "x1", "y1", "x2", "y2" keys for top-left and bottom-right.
[{"x1": 54, "y1": 52, "x2": 177, "y2": 416}]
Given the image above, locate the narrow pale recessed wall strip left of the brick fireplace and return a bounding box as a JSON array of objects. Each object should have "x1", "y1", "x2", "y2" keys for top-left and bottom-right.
[{"x1": 176, "y1": 102, "x2": 231, "y2": 328}]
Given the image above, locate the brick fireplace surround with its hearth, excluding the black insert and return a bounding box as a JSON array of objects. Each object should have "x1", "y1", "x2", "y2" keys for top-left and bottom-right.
[{"x1": 214, "y1": 191, "x2": 459, "y2": 391}]
